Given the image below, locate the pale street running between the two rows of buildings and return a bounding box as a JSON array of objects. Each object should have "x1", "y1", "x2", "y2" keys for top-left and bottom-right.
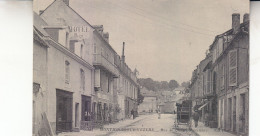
[{"x1": 58, "y1": 114, "x2": 196, "y2": 136}]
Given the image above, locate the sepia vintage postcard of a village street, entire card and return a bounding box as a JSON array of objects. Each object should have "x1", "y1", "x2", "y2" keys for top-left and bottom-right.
[{"x1": 33, "y1": 0, "x2": 250, "y2": 136}]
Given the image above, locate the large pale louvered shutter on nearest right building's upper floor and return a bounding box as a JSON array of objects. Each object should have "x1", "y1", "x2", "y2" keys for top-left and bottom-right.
[{"x1": 229, "y1": 50, "x2": 237, "y2": 86}]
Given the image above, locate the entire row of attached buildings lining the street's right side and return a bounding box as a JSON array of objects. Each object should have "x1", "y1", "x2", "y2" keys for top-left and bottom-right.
[{"x1": 189, "y1": 13, "x2": 249, "y2": 135}]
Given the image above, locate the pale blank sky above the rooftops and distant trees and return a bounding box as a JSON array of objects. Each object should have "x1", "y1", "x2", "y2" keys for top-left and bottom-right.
[{"x1": 33, "y1": 0, "x2": 249, "y2": 83}]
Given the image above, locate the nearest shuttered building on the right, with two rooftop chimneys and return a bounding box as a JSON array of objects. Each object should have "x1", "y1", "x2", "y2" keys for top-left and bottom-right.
[{"x1": 210, "y1": 14, "x2": 249, "y2": 135}]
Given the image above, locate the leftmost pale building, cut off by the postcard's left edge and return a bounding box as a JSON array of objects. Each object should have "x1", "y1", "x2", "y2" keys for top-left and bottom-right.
[{"x1": 33, "y1": 13, "x2": 50, "y2": 135}]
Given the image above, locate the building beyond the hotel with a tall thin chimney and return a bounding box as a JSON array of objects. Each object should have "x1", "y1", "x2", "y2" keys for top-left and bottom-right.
[{"x1": 114, "y1": 42, "x2": 139, "y2": 120}]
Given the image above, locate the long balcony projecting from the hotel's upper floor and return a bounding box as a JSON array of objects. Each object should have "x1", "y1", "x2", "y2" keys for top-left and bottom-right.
[{"x1": 93, "y1": 54, "x2": 119, "y2": 78}]
